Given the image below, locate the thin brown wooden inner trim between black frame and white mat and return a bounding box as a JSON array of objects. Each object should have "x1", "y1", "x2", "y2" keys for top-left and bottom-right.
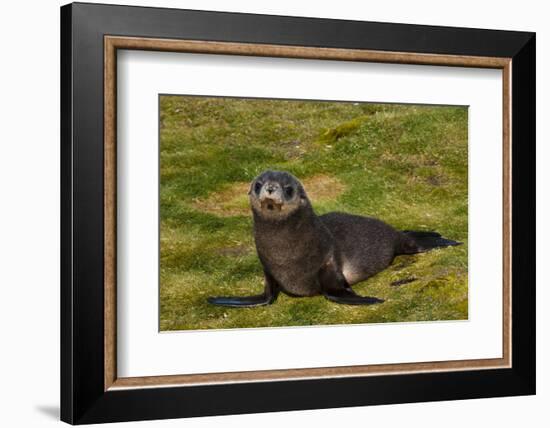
[{"x1": 104, "y1": 36, "x2": 512, "y2": 390}]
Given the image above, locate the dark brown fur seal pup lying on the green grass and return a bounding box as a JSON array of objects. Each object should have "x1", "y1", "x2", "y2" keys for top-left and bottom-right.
[{"x1": 208, "y1": 171, "x2": 460, "y2": 307}]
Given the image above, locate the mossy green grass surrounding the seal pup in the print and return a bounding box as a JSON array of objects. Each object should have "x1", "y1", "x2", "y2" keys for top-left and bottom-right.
[{"x1": 160, "y1": 96, "x2": 468, "y2": 330}]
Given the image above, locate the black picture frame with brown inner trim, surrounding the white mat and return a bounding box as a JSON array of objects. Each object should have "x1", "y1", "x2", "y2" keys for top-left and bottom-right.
[{"x1": 61, "y1": 3, "x2": 536, "y2": 424}]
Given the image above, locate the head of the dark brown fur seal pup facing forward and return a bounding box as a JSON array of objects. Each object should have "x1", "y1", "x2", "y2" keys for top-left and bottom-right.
[{"x1": 248, "y1": 170, "x2": 309, "y2": 220}]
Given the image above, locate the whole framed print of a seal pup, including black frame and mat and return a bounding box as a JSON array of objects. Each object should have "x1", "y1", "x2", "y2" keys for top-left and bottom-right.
[{"x1": 61, "y1": 3, "x2": 535, "y2": 424}]
